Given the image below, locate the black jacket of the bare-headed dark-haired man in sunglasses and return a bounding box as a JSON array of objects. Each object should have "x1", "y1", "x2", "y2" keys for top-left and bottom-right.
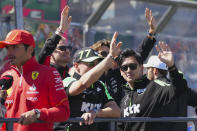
[{"x1": 121, "y1": 68, "x2": 191, "y2": 131}]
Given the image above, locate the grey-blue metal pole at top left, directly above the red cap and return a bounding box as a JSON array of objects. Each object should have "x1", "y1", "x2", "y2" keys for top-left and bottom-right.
[{"x1": 14, "y1": 0, "x2": 24, "y2": 29}]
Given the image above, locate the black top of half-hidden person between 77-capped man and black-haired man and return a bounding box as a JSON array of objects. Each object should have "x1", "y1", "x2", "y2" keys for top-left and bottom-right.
[{"x1": 98, "y1": 37, "x2": 156, "y2": 131}]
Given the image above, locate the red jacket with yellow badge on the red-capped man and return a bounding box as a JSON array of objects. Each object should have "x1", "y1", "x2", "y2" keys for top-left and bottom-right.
[{"x1": 2, "y1": 57, "x2": 70, "y2": 131}]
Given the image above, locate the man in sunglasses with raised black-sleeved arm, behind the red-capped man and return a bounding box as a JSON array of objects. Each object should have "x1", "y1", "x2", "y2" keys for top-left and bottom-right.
[{"x1": 38, "y1": 6, "x2": 72, "y2": 79}]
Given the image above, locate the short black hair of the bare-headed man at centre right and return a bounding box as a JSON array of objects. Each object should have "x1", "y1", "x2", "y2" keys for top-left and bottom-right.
[{"x1": 117, "y1": 48, "x2": 143, "y2": 66}]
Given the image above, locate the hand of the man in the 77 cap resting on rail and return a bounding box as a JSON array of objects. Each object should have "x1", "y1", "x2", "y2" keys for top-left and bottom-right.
[{"x1": 79, "y1": 111, "x2": 96, "y2": 126}]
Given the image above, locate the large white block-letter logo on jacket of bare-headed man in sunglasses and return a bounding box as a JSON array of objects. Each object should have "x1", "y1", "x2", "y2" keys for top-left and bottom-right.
[{"x1": 124, "y1": 104, "x2": 140, "y2": 117}]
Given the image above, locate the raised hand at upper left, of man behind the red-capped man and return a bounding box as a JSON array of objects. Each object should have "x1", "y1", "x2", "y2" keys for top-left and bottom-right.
[{"x1": 59, "y1": 6, "x2": 72, "y2": 32}]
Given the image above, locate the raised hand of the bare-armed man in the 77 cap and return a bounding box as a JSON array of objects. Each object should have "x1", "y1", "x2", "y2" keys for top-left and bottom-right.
[{"x1": 109, "y1": 32, "x2": 122, "y2": 57}]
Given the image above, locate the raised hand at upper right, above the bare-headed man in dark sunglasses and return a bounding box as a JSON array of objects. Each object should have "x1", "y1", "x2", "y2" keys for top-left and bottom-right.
[{"x1": 145, "y1": 8, "x2": 156, "y2": 34}]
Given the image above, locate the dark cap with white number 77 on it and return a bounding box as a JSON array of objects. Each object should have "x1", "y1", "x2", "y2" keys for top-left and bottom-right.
[{"x1": 73, "y1": 47, "x2": 103, "y2": 63}]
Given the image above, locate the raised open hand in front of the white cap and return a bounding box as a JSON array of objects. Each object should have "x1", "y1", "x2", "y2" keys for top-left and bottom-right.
[{"x1": 156, "y1": 41, "x2": 174, "y2": 67}]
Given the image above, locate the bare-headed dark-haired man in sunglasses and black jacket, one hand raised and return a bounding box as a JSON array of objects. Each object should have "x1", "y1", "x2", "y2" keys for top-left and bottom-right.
[{"x1": 118, "y1": 42, "x2": 188, "y2": 131}]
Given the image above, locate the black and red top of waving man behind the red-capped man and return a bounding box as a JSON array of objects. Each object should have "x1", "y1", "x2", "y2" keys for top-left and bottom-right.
[{"x1": 38, "y1": 34, "x2": 70, "y2": 79}]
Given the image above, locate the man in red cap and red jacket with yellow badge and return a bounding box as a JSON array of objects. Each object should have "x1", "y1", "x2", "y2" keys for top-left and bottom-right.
[{"x1": 0, "y1": 29, "x2": 70, "y2": 131}]
